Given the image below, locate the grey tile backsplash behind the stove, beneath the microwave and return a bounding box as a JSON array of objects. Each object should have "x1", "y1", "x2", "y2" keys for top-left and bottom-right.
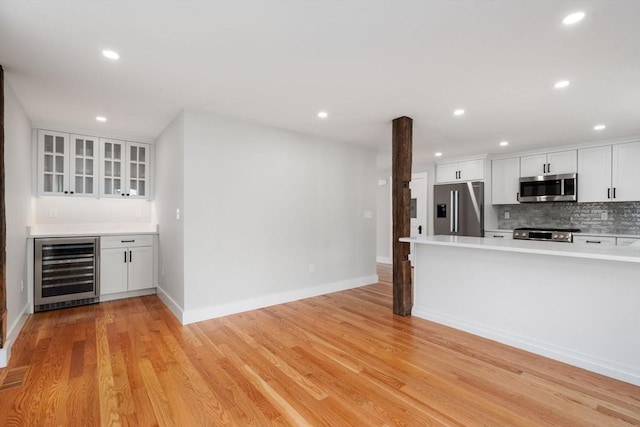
[{"x1": 497, "y1": 202, "x2": 640, "y2": 235}]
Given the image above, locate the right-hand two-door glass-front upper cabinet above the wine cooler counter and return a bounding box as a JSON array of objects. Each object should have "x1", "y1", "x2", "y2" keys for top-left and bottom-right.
[{"x1": 100, "y1": 138, "x2": 150, "y2": 199}]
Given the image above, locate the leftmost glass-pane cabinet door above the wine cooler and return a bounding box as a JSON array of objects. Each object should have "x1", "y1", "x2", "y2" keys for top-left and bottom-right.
[{"x1": 38, "y1": 130, "x2": 69, "y2": 196}]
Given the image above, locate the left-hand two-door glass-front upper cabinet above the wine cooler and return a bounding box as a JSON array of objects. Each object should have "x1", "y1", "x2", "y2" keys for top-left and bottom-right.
[{"x1": 37, "y1": 129, "x2": 98, "y2": 197}]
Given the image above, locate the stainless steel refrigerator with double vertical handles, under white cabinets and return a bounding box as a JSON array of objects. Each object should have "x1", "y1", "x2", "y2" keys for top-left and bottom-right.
[{"x1": 433, "y1": 181, "x2": 484, "y2": 237}]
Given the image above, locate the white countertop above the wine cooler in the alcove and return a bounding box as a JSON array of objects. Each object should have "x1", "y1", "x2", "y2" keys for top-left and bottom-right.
[{"x1": 27, "y1": 223, "x2": 158, "y2": 238}]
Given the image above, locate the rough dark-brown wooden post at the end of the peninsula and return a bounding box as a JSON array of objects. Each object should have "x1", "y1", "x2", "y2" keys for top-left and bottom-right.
[{"x1": 391, "y1": 116, "x2": 413, "y2": 316}]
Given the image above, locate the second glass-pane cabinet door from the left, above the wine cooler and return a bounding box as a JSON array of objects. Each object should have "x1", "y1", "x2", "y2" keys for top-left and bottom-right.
[{"x1": 69, "y1": 135, "x2": 98, "y2": 196}]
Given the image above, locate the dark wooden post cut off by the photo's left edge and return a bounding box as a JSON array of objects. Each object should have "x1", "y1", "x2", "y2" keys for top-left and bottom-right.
[{"x1": 0, "y1": 65, "x2": 7, "y2": 348}]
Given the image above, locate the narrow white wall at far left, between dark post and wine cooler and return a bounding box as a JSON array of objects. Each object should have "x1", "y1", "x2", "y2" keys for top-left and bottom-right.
[{"x1": 0, "y1": 77, "x2": 32, "y2": 367}]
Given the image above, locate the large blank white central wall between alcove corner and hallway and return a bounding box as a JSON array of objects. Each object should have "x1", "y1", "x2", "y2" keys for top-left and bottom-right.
[{"x1": 180, "y1": 111, "x2": 376, "y2": 322}]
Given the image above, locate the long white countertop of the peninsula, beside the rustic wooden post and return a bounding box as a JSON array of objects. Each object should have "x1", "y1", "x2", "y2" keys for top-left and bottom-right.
[{"x1": 400, "y1": 236, "x2": 640, "y2": 264}]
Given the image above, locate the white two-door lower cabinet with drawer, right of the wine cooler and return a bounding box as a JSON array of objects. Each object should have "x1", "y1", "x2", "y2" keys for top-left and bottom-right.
[{"x1": 100, "y1": 235, "x2": 153, "y2": 295}]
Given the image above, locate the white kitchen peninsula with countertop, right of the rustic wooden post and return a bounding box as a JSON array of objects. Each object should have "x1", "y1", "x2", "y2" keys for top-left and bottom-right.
[{"x1": 400, "y1": 236, "x2": 640, "y2": 385}]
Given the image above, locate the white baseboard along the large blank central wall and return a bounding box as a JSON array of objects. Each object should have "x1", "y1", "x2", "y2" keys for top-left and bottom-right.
[{"x1": 182, "y1": 274, "x2": 378, "y2": 325}]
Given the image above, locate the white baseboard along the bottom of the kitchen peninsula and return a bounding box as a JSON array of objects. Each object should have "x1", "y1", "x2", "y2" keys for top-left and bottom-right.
[{"x1": 412, "y1": 307, "x2": 640, "y2": 386}]
